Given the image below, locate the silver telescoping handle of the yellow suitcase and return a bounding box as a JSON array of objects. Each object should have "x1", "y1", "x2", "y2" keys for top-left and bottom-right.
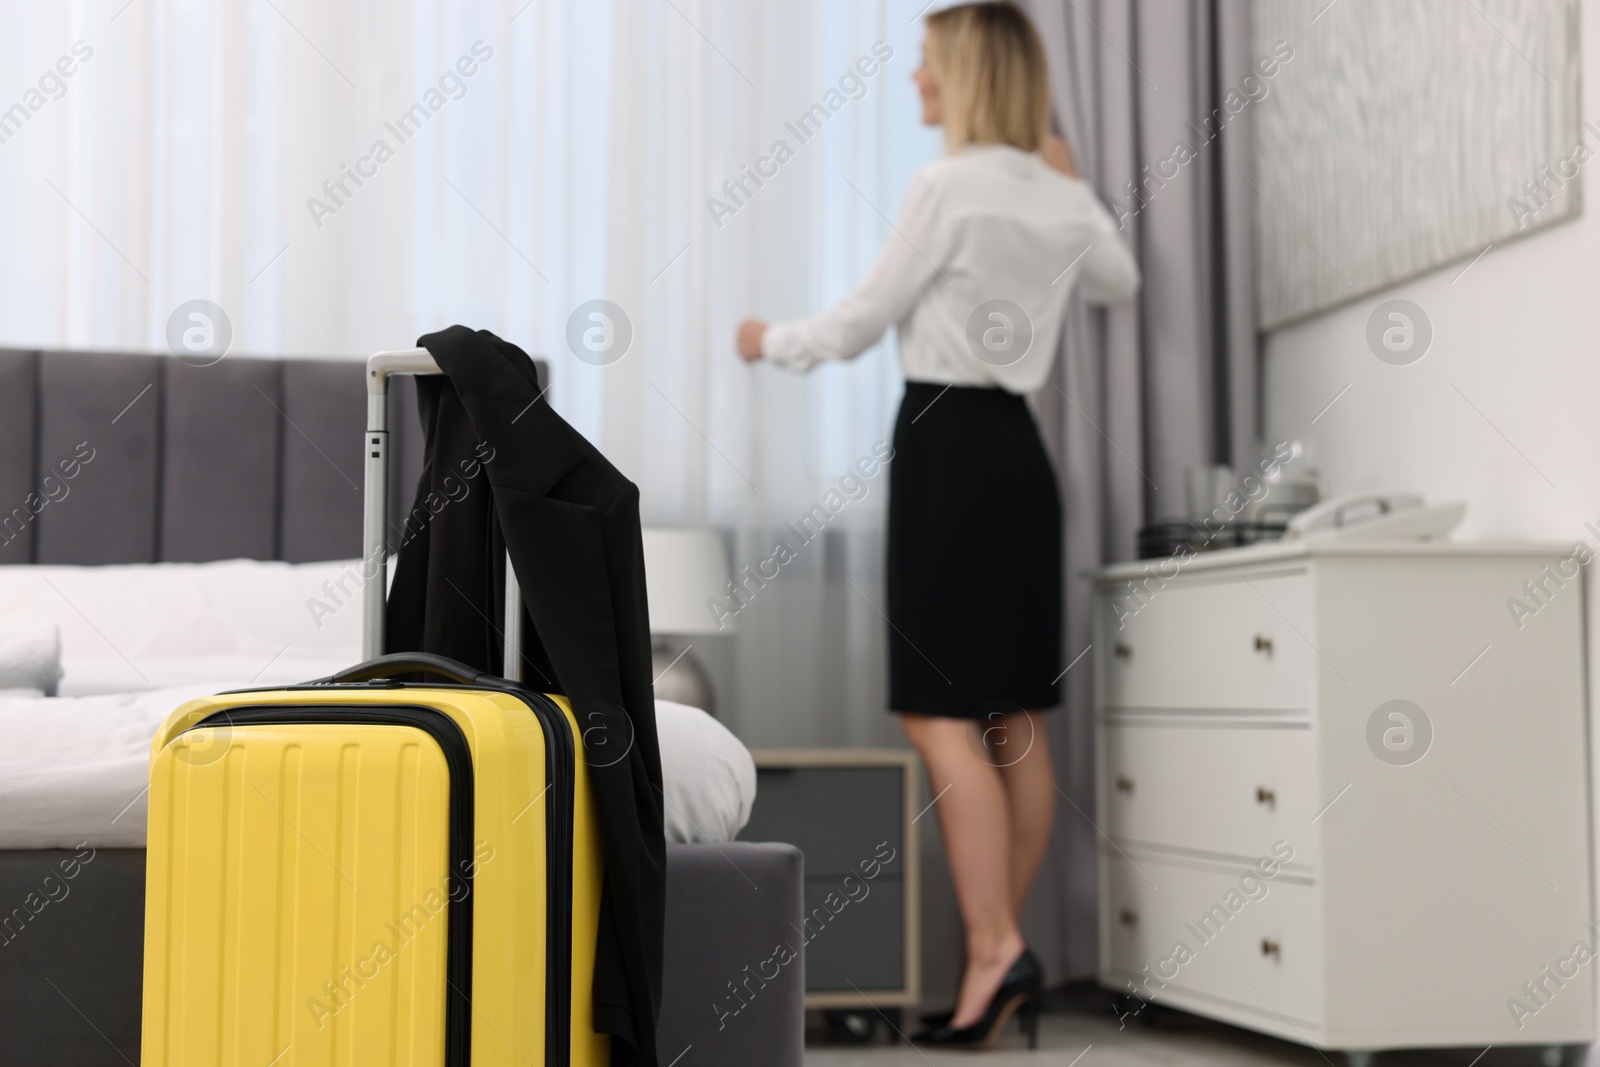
[{"x1": 362, "y1": 349, "x2": 522, "y2": 681}]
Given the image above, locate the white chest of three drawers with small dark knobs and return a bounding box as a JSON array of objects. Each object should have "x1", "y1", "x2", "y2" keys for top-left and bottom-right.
[{"x1": 1093, "y1": 541, "x2": 1600, "y2": 1054}]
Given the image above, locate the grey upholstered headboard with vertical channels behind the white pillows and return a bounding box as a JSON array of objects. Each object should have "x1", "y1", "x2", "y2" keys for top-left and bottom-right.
[{"x1": 0, "y1": 349, "x2": 547, "y2": 565}]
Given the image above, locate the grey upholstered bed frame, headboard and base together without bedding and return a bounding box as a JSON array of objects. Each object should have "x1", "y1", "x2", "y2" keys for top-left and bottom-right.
[{"x1": 0, "y1": 349, "x2": 805, "y2": 1067}]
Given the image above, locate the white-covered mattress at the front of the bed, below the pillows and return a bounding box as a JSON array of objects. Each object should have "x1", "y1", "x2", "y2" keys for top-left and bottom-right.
[{"x1": 0, "y1": 694, "x2": 755, "y2": 849}]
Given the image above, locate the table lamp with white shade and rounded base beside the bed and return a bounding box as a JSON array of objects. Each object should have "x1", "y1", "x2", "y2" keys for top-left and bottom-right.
[{"x1": 643, "y1": 526, "x2": 736, "y2": 715}]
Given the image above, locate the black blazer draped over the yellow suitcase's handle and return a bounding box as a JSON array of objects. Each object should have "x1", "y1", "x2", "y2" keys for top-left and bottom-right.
[{"x1": 384, "y1": 326, "x2": 666, "y2": 1067}]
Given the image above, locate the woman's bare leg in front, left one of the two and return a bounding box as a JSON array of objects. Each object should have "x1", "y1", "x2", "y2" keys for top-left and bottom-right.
[{"x1": 901, "y1": 713, "x2": 1024, "y2": 1027}]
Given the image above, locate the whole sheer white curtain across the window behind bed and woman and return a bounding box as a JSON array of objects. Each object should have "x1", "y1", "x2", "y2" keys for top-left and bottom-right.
[{"x1": 0, "y1": 0, "x2": 939, "y2": 744}]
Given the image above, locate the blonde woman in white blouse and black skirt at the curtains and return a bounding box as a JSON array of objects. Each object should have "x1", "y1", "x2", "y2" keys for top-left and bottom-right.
[{"x1": 738, "y1": 3, "x2": 1139, "y2": 1048}]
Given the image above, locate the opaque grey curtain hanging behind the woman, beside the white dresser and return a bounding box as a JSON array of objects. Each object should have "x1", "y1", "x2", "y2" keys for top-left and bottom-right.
[{"x1": 1024, "y1": 0, "x2": 1259, "y2": 981}]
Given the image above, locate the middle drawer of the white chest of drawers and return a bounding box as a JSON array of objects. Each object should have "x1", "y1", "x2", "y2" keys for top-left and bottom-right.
[{"x1": 1101, "y1": 717, "x2": 1320, "y2": 865}]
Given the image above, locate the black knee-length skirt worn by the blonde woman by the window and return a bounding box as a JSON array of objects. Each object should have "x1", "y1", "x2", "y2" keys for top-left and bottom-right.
[{"x1": 886, "y1": 382, "x2": 1062, "y2": 718}]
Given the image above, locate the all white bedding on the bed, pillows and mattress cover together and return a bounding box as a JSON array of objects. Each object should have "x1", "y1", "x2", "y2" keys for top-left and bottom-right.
[{"x1": 0, "y1": 560, "x2": 755, "y2": 848}]
